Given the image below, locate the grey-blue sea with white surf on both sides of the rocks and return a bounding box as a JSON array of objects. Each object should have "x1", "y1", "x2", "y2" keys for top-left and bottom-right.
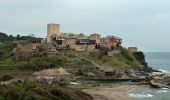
[{"x1": 127, "y1": 52, "x2": 170, "y2": 100}]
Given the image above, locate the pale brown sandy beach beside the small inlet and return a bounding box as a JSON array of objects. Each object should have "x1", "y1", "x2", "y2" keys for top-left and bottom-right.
[{"x1": 83, "y1": 85, "x2": 137, "y2": 100}]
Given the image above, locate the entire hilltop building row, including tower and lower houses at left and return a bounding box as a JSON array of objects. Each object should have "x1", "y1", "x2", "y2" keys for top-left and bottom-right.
[{"x1": 13, "y1": 24, "x2": 125, "y2": 56}]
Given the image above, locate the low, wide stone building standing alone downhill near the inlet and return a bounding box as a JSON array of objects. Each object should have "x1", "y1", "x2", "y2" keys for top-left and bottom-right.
[{"x1": 33, "y1": 68, "x2": 70, "y2": 83}]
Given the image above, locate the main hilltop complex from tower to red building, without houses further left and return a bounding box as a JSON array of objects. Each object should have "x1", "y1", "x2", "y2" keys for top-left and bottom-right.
[{"x1": 44, "y1": 24, "x2": 122, "y2": 51}]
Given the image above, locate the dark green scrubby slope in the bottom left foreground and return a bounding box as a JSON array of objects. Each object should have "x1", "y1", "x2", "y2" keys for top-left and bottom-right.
[{"x1": 0, "y1": 80, "x2": 93, "y2": 100}]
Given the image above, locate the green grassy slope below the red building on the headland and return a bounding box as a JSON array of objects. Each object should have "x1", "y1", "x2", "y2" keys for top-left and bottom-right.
[{"x1": 85, "y1": 48, "x2": 141, "y2": 68}]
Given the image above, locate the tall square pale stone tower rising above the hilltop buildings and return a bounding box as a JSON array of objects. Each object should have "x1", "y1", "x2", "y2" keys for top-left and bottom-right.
[{"x1": 47, "y1": 23, "x2": 60, "y2": 43}]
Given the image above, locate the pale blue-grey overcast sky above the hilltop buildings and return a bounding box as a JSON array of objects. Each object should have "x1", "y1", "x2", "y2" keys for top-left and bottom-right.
[{"x1": 0, "y1": 0, "x2": 170, "y2": 52}]
